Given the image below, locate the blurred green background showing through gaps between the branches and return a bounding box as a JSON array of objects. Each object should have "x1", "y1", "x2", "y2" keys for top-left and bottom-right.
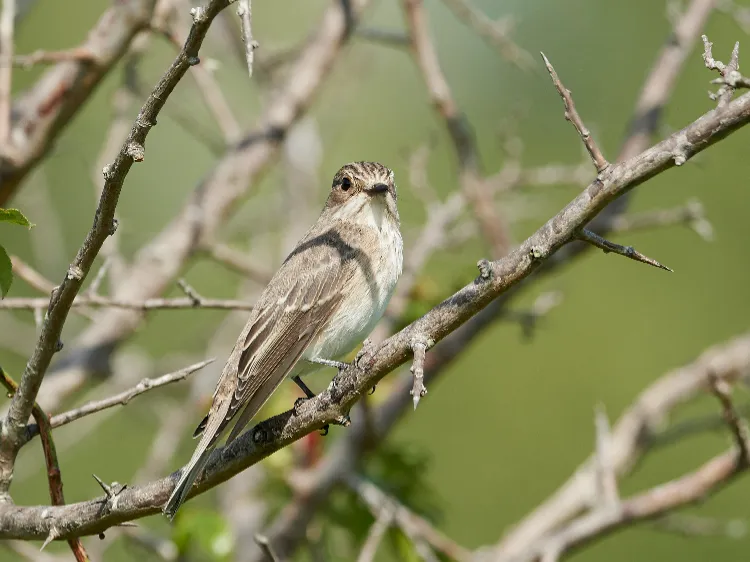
[{"x1": 0, "y1": 0, "x2": 750, "y2": 562}]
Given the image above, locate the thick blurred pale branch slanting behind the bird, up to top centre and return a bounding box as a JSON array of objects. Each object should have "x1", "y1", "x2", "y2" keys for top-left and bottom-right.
[{"x1": 40, "y1": 0, "x2": 370, "y2": 409}]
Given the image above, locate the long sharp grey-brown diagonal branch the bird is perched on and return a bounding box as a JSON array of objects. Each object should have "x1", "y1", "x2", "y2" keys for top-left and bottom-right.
[{"x1": 0, "y1": 58, "x2": 750, "y2": 539}]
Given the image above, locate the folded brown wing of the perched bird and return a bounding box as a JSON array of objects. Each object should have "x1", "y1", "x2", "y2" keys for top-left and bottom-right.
[{"x1": 206, "y1": 242, "x2": 355, "y2": 443}]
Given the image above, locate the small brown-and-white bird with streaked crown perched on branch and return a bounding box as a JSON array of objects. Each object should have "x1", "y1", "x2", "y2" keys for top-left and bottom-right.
[{"x1": 162, "y1": 162, "x2": 403, "y2": 520}]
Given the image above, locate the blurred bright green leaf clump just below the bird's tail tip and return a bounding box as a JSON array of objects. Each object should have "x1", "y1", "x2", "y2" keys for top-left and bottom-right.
[{"x1": 172, "y1": 507, "x2": 234, "y2": 561}]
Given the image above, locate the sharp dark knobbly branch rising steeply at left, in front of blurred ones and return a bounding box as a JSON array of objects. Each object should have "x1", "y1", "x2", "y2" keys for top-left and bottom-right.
[{"x1": 0, "y1": 0, "x2": 228, "y2": 494}]
